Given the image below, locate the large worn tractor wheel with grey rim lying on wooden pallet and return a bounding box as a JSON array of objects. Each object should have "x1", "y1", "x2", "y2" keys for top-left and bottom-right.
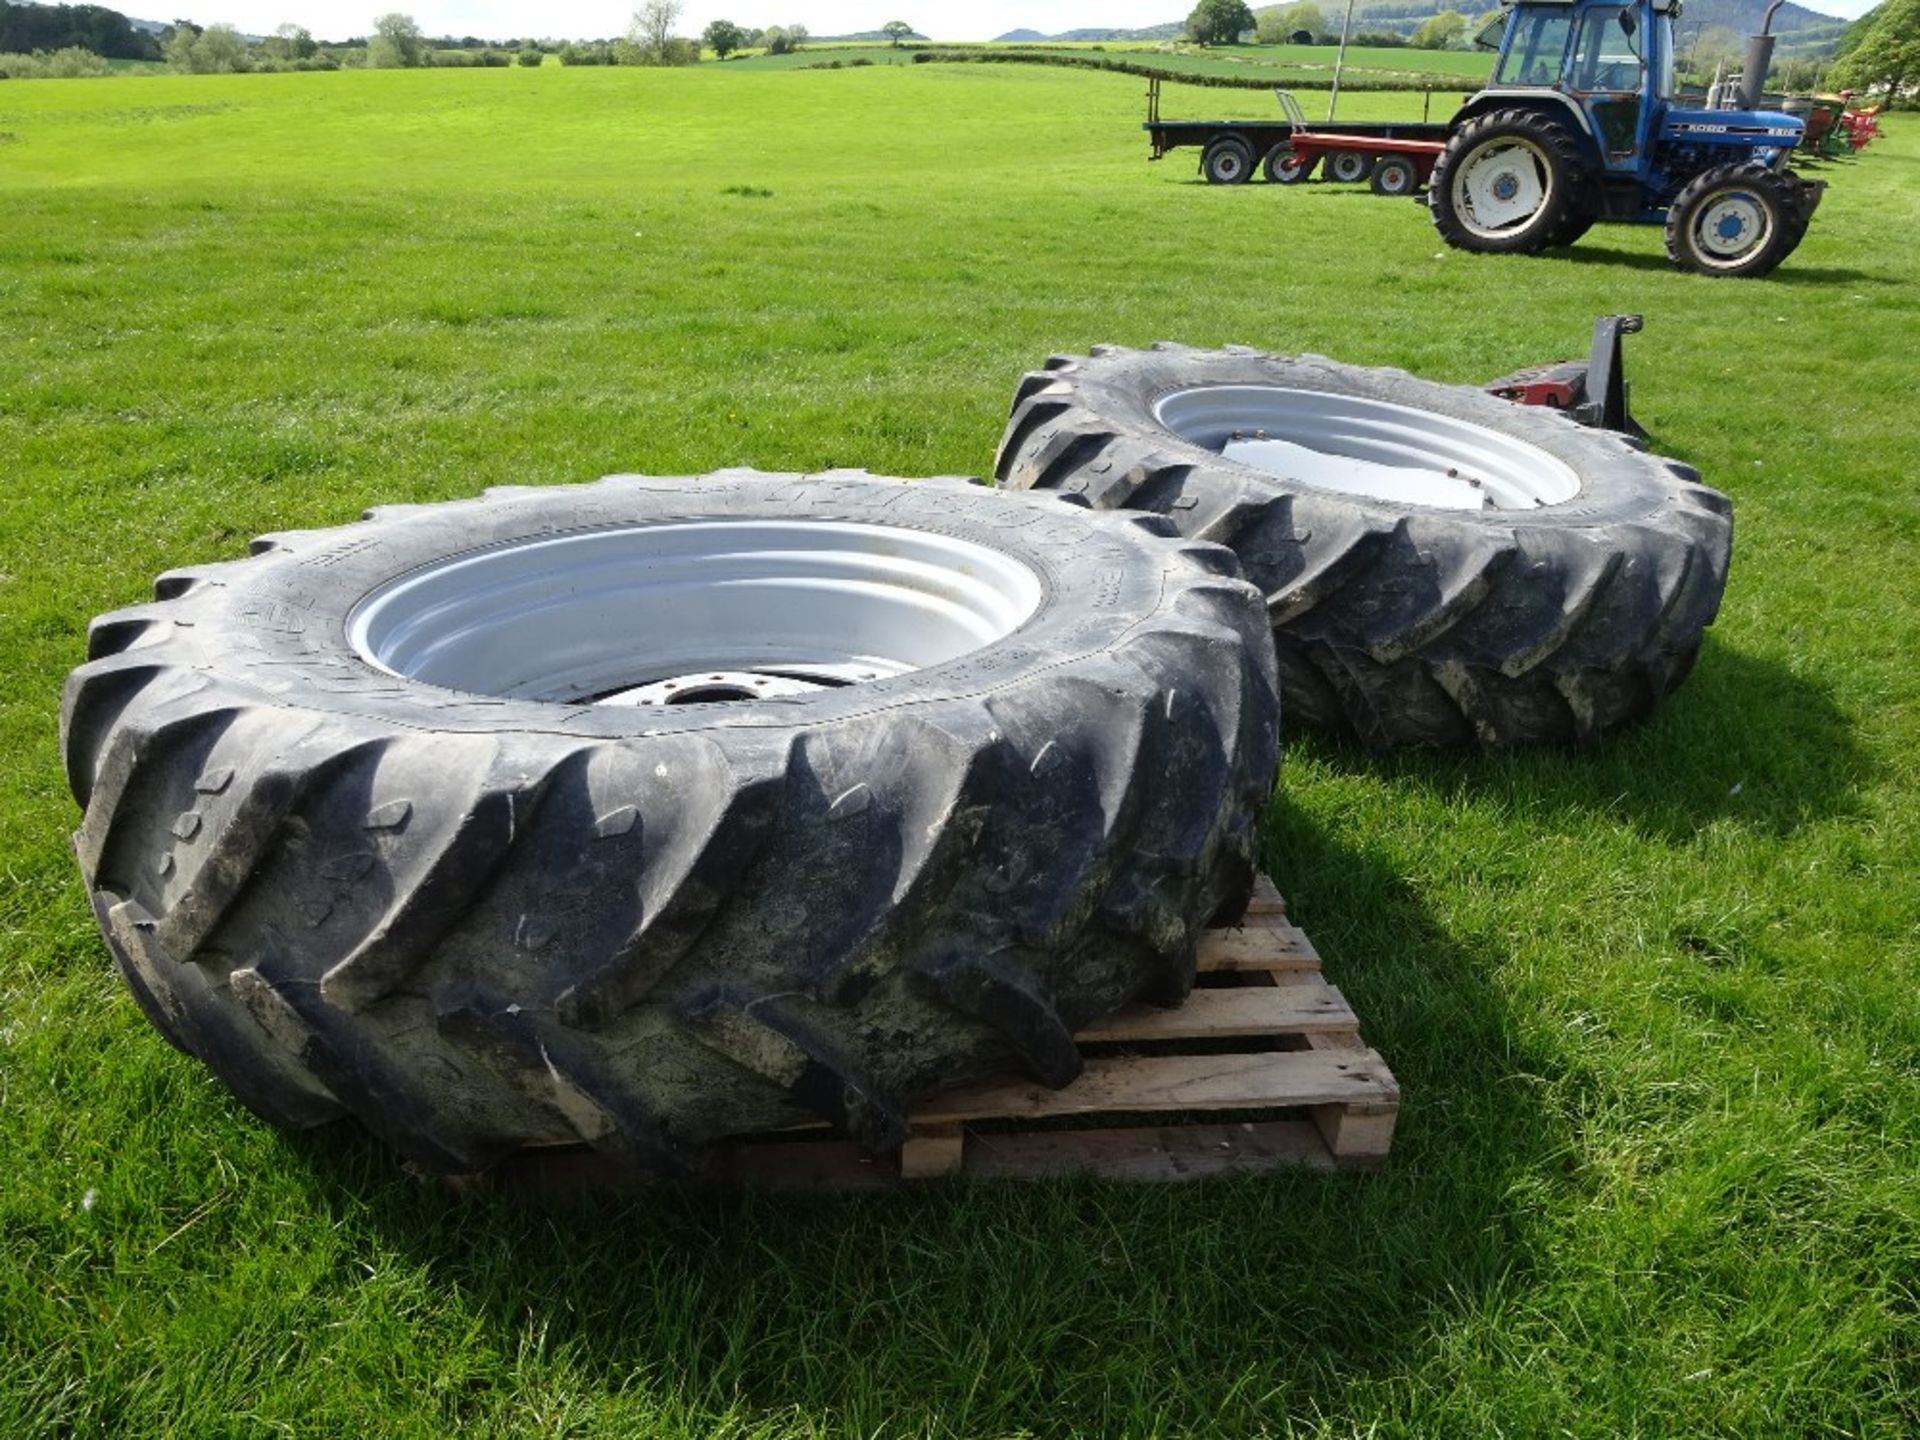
[{"x1": 61, "y1": 472, "x2": 1279, "y2": 1171}]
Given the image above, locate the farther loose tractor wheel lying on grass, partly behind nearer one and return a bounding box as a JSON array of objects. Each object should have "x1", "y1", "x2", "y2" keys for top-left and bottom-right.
[{"x1": 996, "y1": 346, "x2": 1732, "y2": 749}]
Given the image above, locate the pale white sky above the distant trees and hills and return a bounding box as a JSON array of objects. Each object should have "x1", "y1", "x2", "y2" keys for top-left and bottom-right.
[{"x1": 172, "y1": 0, "x2": 1876, "y2": 40}]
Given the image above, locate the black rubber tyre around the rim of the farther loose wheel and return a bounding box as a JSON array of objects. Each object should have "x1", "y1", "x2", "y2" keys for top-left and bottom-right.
[{"x1": 995, "y1": 344, "x2": 1732, "y2": 751}]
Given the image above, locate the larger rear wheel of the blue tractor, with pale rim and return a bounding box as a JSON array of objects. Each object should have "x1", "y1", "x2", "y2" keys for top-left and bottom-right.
[{"x1": 1427, "y1": 109, "x2": 1592, "y2": 255}]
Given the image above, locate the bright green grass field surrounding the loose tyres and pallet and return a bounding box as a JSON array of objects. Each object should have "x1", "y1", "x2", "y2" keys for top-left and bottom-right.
[{"x1": 0, "y1": 65, "x2": 1920, "y2": 1440}]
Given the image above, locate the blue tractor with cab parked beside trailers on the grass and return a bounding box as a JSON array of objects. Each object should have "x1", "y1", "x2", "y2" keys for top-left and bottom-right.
[{"x1": 1427, "y1": 0, "x2": 1826, "y2": 276}]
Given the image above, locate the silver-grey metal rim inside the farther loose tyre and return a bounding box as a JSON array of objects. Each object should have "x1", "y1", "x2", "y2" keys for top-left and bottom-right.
[{"x1": 1154, "y1": 386, "x2": 1580, "y2": 511}]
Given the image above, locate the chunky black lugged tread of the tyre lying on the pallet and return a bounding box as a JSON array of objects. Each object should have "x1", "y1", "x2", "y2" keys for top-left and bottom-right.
[{"x1": 61, "y1": 474, "x2": 1279, "y2": 1171}]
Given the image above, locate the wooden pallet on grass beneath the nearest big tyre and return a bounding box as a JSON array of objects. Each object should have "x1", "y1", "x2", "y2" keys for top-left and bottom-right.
[{"x1": 483, "y1": 879, "x2": 1400, "y2": 1192}]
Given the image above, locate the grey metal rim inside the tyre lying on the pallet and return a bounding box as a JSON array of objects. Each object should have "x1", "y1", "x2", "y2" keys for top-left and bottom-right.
[{"x1": 348, "y1": 518, "x2": 1041, "y2": 707}]
